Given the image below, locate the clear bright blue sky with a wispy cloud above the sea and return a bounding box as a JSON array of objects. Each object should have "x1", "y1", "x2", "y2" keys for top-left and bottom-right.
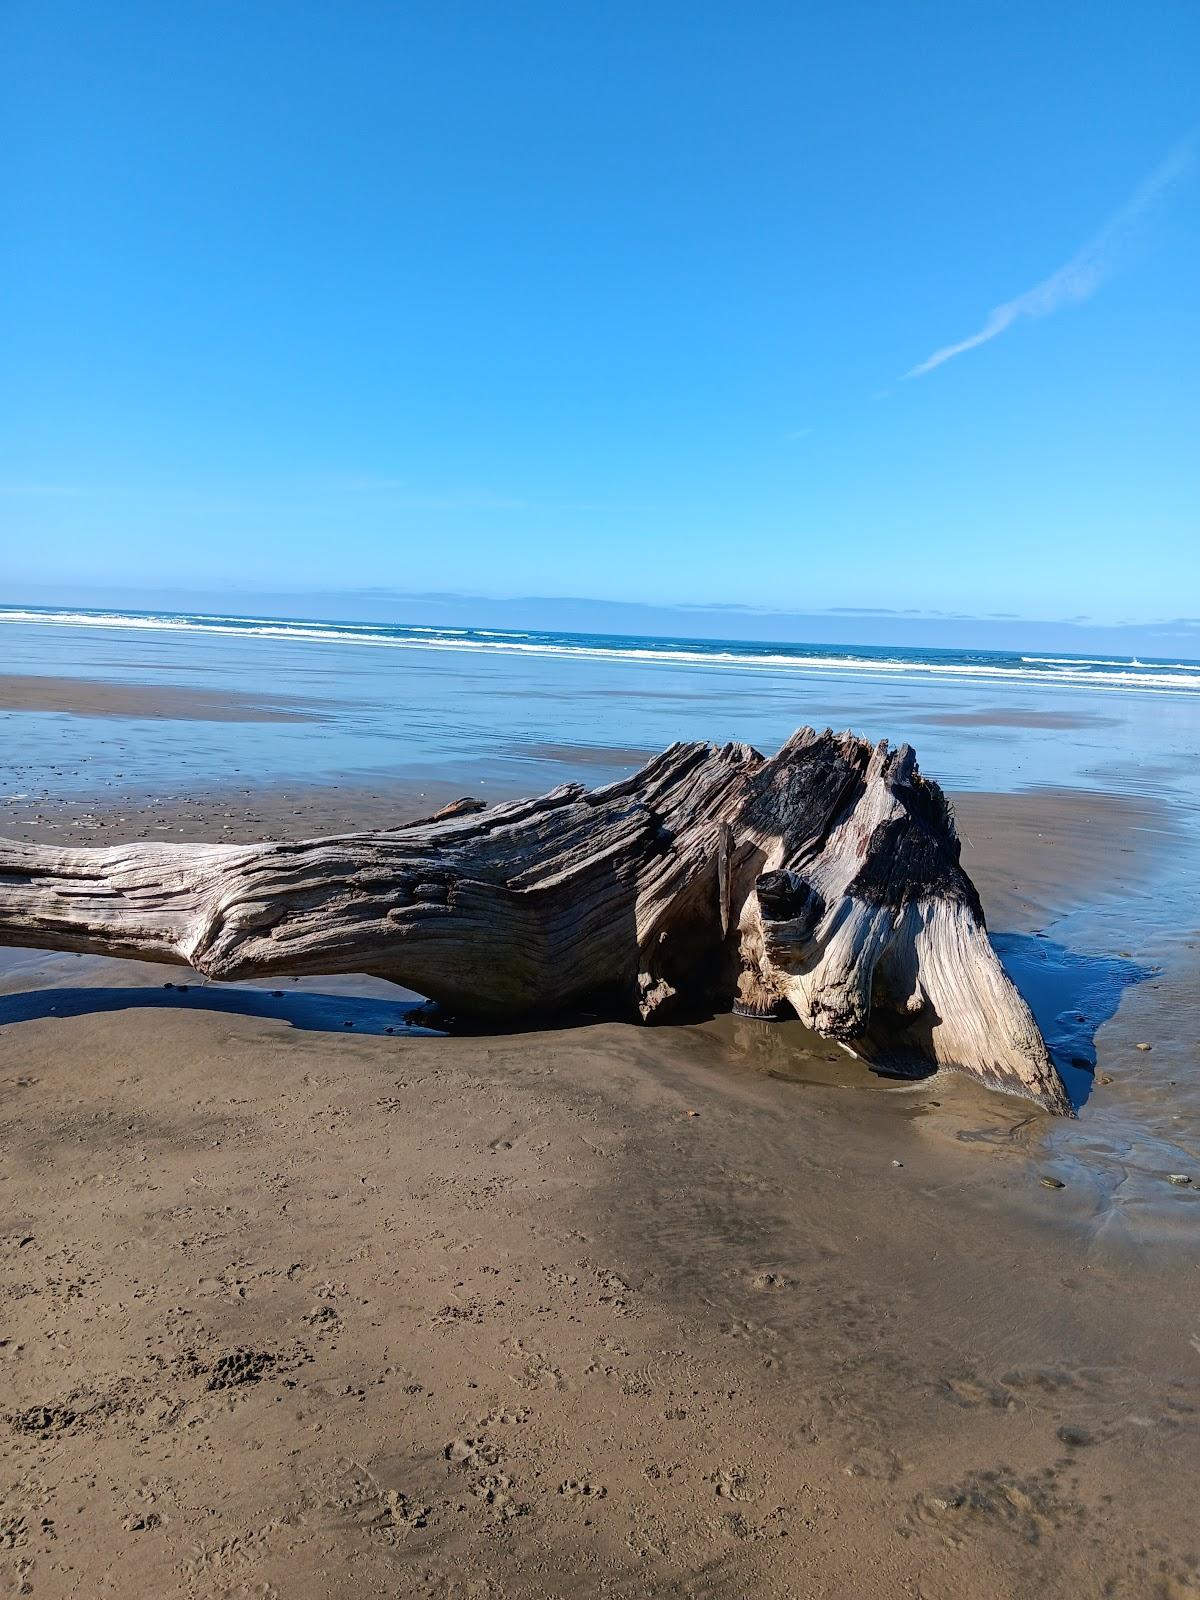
[{"x1": 0, "y1": 0, "x2": 1200, "y2": 636}]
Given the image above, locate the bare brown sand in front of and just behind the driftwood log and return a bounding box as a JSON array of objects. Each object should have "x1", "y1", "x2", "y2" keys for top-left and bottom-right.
[{"x1": 0, "y1": 787, "x2": 1200, "y2": 1600}]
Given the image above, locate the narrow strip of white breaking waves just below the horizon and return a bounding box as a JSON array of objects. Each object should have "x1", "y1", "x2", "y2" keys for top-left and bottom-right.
[{"x1": 0, "y1": 608, "x2": 1200, "y2": 694}]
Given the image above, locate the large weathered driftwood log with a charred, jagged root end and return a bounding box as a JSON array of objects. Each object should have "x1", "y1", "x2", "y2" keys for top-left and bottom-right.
[{"x1": 0, "y1": 728, "x2": 1070, "y2": 1114}]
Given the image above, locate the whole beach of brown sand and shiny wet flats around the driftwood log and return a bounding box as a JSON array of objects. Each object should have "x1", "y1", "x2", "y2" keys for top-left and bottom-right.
[{"x1": 0, "y1": 622, "x2": 1200, "y2": 1600}]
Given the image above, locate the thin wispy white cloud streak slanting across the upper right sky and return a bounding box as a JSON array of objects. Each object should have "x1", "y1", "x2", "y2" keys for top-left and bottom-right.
[{"x1": 904, "y1": 133, "x2": 1197, "y2": 378}]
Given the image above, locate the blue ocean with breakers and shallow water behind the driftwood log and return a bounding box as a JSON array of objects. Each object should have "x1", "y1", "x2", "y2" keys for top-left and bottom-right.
[{"x1": 0, "y1": 606, "x2": 1200, "y2": 802}]
